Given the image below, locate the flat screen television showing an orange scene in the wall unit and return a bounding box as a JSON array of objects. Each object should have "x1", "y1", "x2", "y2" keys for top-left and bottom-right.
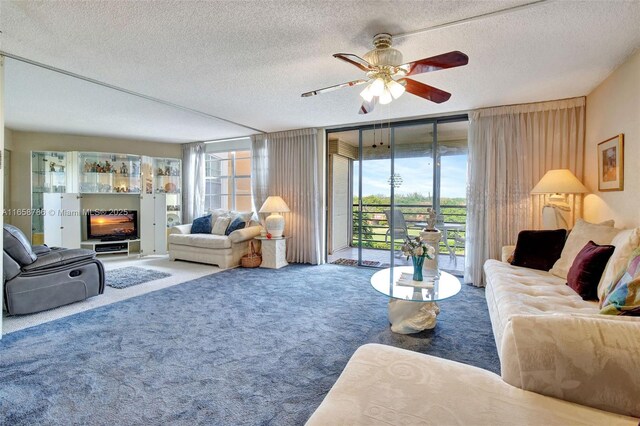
[{"x1": 87, "y1": 210, "x2": 138, "y2": 240}]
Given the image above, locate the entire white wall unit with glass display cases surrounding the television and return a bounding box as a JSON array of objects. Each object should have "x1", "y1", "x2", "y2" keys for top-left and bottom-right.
[{"x1": 31, "y1": 152, "x2": 182, "y2": 254}]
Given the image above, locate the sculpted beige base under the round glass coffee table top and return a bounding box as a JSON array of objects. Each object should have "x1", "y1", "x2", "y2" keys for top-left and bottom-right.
[{"x1": 388, "y1": 299, "x2": 440, "y2": 334}]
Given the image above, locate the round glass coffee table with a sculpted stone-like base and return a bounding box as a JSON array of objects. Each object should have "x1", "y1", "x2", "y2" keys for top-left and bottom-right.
[{"x1": 371, "y1": 266, "x2": 462, "y2": 334}]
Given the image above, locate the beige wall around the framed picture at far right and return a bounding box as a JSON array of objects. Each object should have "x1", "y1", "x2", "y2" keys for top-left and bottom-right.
[{"x1": 584, "y1": 51, "x2": 640, "y2": 228}]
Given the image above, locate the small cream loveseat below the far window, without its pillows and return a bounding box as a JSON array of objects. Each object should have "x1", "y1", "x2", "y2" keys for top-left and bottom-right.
[{"x1": 168, "y1": 224, "x2": 262, "y2": 269}]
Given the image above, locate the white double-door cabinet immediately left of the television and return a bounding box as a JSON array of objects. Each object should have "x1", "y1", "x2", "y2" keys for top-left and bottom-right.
[{"x1": 42, "y1": 193, "x2": 82, "y2": 248}]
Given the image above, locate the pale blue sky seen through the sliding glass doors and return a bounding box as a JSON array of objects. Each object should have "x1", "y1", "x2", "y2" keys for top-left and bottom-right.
[{"x1": 353, "y1": 155, "x2": 467, "y2": 198}]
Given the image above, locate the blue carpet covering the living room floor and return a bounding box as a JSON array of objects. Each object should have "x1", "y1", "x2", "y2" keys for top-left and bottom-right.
[{"x1": 0, "y1": 265, "x2": 499, "y2": 425}]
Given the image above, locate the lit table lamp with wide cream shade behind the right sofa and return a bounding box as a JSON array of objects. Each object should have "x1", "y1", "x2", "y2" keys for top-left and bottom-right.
[{"x1": 531, "y1": 169, "x2": 589, "y2": 229}]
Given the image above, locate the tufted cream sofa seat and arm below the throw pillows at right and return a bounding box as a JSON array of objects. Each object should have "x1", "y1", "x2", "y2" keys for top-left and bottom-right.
[{"x1": 484, "y1": 255, "x2": 640, "y2": 417}]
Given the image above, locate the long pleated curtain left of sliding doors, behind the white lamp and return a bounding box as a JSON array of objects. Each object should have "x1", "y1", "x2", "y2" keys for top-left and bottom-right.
[{"x1": 251, "y1": 129, "x2": 323, "y2": 264}]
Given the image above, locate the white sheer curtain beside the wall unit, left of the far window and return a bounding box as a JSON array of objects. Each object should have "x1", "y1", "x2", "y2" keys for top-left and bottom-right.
[{"x1": 182, "y1": 142, "x2": 205, "y2": 223}]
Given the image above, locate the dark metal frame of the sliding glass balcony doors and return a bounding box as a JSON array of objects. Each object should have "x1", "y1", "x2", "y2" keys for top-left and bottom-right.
[{"x1": 324, "y1": 113, "x2": 469, "y2": 266}]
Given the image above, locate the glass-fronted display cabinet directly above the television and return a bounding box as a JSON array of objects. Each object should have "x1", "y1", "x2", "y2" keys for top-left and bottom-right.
[{"x1": 78, "y1": 152, "x2": 141, "y2": 194}]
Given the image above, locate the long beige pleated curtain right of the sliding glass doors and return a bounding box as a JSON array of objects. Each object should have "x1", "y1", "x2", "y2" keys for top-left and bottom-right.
[{"x1": 464, "y1": 98, "x2": 585, "y2": 286}]
